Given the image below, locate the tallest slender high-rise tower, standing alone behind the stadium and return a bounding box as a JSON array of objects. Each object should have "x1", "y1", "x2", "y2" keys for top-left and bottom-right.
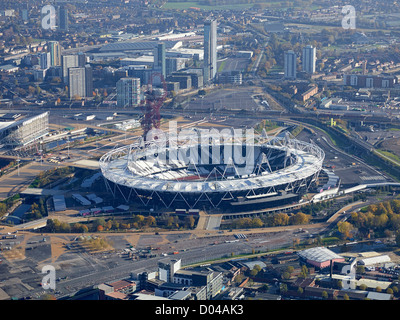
[{"x1": 203, "y1": 20, "x2": 217, "y2": 82}]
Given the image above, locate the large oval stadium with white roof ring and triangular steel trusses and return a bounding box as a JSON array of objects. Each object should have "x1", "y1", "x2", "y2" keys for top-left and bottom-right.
[{"x1": 100, "y1": 132, "x2": 325, "y2": 211}]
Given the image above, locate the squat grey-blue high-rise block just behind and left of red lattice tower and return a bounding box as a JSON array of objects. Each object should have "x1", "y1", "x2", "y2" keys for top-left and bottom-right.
[{"x1": 117, "y1": 78, "x2": 140, "y2": 108}]
